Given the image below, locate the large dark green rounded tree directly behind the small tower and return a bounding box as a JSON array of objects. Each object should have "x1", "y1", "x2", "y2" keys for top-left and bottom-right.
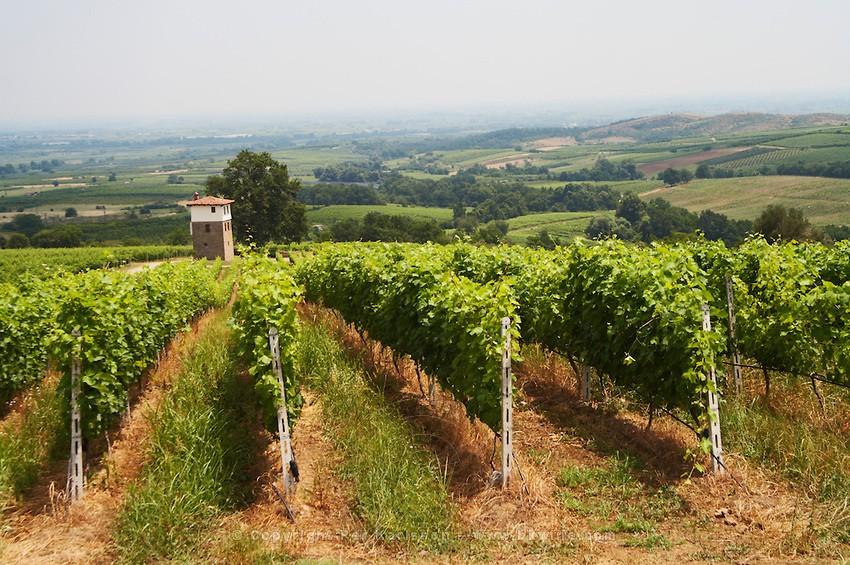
[{"x1": 207, "y1": 150, "x2": 307, "y2": 243}]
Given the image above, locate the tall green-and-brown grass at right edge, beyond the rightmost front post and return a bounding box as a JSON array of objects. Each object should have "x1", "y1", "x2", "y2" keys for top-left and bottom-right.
[{"x1": 721, "y1": 364, "x2": 850, "y2": 556}]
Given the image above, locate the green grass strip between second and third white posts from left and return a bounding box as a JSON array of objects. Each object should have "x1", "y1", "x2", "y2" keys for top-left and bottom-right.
[{"x1": 298, "y1": 325, "x2": 455, "y2": 551}]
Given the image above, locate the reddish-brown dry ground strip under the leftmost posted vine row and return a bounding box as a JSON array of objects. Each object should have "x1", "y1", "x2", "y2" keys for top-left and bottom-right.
[{"x1": 0, "y1": 311, "x2": 222, "y2": 563}]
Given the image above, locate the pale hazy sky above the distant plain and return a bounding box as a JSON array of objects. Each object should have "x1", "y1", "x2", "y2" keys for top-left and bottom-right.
[{"x1": 0, "y1": 0, "x2": 850, "y2": 123}]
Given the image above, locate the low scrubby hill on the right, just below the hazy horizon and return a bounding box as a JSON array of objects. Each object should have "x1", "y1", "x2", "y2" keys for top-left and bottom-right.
[{"x1": 577, "y1": 112, "x2": 850, "y2": 142}]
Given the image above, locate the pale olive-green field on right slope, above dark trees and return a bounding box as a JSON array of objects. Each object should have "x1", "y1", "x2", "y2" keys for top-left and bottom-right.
[{"x1": 641, "y1": 176, "x2": 850, "y2": 225}]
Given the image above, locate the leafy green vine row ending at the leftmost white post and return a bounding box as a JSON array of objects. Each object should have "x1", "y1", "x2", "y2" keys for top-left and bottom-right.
[{"x1": 48, "y1": 261, "x2": 221, "y2": 435}]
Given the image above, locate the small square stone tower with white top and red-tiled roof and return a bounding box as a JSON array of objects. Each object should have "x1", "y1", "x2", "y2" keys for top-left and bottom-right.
[{"x1": 186, "y1": 192, "x2": 233, "y2": 261}]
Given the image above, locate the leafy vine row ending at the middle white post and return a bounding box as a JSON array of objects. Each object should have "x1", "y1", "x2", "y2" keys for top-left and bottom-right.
[{"x1": 297, "y1": 244, "x2": 519, "y2": 429}]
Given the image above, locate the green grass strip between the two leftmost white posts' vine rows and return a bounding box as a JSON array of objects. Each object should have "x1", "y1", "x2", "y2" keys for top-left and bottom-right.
[{"x1": 113, "y1": 311, "x2": 254, "y2": 563}]
